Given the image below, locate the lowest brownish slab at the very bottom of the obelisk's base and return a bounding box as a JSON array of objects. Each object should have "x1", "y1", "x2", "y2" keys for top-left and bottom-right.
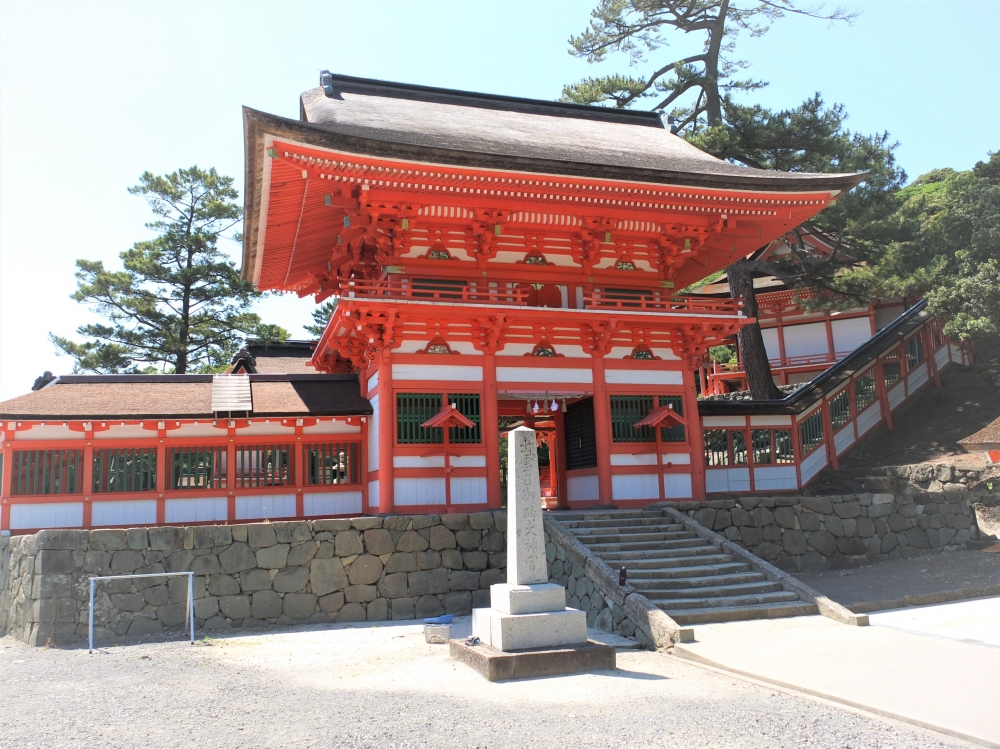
[{"x1": 449, "y1": 636, "x2": 616, "y2": 681}]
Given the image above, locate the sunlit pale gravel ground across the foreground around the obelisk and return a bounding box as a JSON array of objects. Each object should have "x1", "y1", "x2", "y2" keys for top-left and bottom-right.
[{"x1": 0, "y1": 620, "x2": 968, "y2": 749}]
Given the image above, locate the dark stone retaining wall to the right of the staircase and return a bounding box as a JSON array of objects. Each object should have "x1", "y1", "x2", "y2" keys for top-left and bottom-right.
[{"x1": 673, "y1": 490, "x2": 980, "y2": 572}]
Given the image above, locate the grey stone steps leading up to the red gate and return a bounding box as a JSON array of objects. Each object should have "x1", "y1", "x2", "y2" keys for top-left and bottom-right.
[{"x1": 551, "y1": 510, "x2": 818, "y2": 625}]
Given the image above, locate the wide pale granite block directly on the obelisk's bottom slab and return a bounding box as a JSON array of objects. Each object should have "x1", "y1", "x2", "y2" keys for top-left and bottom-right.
[{"x1": 472, "y1": 609, "x2": 587, "y2": 652}]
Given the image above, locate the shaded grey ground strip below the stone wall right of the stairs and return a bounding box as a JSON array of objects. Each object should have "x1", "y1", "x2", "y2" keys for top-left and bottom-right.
[{"x1": 797, "y1": 551, "x2": 1000, "y2": 606}]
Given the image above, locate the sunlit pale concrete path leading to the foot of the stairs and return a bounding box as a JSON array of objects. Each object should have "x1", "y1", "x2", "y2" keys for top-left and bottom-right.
[{"x1": 674, "y1": 599, "x2": 1000, "y2": 747}]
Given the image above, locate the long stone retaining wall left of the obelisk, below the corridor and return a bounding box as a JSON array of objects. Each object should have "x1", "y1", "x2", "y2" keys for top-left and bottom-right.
[{"x1": 0, "y1": 511, "x2": 507, "y2": 645}]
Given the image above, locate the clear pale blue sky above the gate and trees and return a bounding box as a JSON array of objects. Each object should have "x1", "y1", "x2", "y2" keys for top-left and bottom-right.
[{"x1": 0, "y1": 0, "x2": 1000, "y2": 399}]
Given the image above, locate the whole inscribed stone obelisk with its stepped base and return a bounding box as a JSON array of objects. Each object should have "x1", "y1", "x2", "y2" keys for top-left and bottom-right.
[{"x1": 451, "y1": 427, "x2": 615, "y2": 681}]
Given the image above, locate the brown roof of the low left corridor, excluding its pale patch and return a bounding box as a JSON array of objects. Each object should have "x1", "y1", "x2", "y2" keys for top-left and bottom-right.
[{"x1": 0, "y1": 373, "x2": 372, "y2": 421}]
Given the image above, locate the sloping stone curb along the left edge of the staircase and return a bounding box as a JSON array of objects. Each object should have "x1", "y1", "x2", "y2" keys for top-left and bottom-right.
[{"x1": 542, "y1": 515, "x2": 694, "y2": 648}]
